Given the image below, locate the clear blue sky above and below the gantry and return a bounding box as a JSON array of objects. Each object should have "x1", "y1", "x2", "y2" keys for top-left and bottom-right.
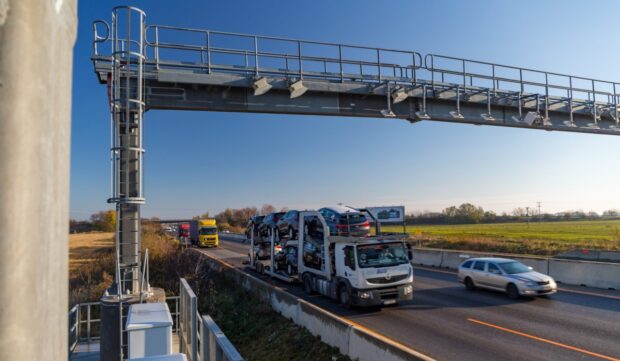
[{"x1": 71, "y1": 0, "x2": 620, "y2": 219}]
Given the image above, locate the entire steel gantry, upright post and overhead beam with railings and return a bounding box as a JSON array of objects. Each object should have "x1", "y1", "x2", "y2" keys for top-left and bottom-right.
[{"x1": 92, "y1": 7, "x2": 620, "y2": 358}]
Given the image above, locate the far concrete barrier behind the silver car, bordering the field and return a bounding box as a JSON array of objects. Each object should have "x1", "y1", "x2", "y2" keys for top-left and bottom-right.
[{"x1": 413, "y1": 248, "x2": 620, "y2": 289}]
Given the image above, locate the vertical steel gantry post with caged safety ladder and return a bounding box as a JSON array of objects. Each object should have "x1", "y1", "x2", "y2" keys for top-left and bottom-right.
[{"x1": 108, "y1": 6, "x2": 145, "y2": 295}]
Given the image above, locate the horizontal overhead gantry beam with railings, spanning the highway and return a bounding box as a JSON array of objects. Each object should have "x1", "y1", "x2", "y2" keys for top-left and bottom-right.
[{"x1": 93, "y1": 21, "x2": 620, "y2": 135}]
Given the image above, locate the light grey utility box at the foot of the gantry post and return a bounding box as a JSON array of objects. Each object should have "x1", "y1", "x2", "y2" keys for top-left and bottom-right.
[{"x1": 126, "y1": 302, "x2": 172, "y2": 359}]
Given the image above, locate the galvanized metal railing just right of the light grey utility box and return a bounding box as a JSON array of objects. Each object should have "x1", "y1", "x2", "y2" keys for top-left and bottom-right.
[{"x1": 178, "y1": 278, "x2": 243, "y2": 361}]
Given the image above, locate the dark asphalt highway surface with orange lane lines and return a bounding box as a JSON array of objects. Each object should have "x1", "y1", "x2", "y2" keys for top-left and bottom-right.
[{"x1": 202, "y1": 235, "x2": 620, "y2": 361}]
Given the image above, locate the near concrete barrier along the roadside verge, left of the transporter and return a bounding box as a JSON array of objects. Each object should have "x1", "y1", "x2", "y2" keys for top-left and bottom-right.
[{"x1": 200, "y1": 248, "x2": 433, "y2": 361}]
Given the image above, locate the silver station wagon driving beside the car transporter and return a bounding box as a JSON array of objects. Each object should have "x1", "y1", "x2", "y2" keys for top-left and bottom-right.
[{"x1": 458, "y1": 257, "x2": 558, "y2": 298}]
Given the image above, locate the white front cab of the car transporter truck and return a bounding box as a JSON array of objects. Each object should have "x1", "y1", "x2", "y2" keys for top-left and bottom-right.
[{"x1": 298, "y1": 211, "x2": 413, "y2": 307}]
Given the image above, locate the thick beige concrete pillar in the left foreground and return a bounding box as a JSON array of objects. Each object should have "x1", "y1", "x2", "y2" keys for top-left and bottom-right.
[{"x1": 0, "y1": 0, "x2": 77, "y2": 361}]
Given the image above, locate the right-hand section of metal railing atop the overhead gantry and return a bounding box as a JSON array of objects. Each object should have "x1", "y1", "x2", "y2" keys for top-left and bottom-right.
[{"x1": 424, "y1": 54, "x2": 620, "y2": 124}]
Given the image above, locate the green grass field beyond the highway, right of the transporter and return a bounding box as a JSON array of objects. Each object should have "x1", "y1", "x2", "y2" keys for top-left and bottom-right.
[{"x1": 384, "y1": 220, "x2": 620, "y2": 255}]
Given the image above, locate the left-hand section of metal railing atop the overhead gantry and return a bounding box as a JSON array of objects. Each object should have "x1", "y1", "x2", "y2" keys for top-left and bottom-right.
[{"x1": 145, "y1": 25, "x2": 422, "y2": 81}]
